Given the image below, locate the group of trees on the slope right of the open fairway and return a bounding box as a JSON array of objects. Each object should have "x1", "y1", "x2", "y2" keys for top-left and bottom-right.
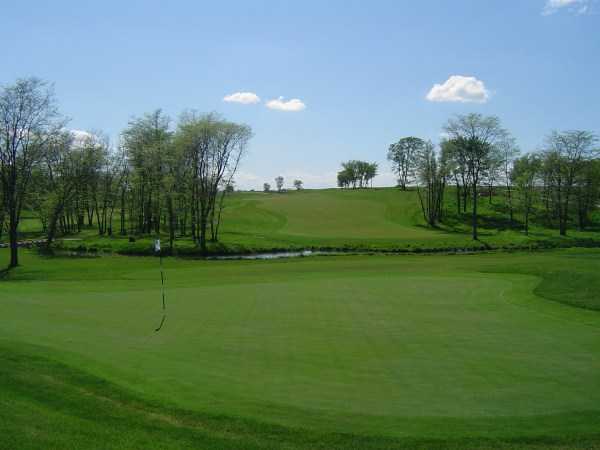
[{"x1": 388, "y1": 114, "x2": 600, "y2": 239}]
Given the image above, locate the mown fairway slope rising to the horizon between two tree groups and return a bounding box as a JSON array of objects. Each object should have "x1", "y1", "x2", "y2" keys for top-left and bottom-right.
[{"x1": 216, "y1": 189, "x2": 474, "y2": 246}]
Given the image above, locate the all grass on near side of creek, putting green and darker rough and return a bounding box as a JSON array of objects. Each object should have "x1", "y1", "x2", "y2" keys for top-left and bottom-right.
[{"x1": 0, "y1": 248, "x2": 600, "y2": 449}]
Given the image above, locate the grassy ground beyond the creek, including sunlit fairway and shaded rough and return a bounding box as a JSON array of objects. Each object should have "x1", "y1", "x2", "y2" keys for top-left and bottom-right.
[{"x1": 36, "y1": 188, "x2": 600, "y2": 254}]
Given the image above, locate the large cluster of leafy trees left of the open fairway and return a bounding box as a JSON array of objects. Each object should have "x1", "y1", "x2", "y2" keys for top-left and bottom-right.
[{"x1": 0, "y1": 78, "x2": 252, "y2": 267}]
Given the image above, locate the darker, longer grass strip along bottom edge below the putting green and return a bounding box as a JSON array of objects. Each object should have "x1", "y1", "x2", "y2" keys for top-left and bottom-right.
[{"x1": 0, "y1": 341, "x2": 600, "y2": 450}]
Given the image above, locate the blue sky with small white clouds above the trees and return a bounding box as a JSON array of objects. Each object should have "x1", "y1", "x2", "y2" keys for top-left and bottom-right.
[{"x1": 0, "y1": 0, "x2": 600, "y2": 189}]
